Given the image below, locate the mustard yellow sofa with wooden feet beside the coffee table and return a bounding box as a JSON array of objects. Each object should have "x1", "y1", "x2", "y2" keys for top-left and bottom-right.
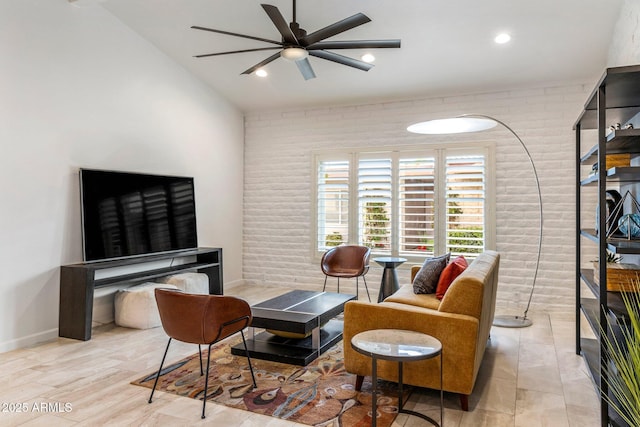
[{"x1": 343, "y1": 251, "x2": 500, "y2": 411}]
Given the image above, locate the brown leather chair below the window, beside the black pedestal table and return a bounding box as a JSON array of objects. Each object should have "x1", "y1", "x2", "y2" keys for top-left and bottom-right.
[{"x1": 320, "y1": 245, "x2": 371, "y2": 301}]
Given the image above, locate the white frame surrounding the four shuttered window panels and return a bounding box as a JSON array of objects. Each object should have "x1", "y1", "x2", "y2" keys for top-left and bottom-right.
[{"x1": 310, "y1": 141, "x2": 496, "y2": 263}]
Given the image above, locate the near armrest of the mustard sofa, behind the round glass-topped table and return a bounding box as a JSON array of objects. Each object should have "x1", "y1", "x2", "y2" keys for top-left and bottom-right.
[{"x1": 343, "y1": 301, "x2": 478, "y2": 394}]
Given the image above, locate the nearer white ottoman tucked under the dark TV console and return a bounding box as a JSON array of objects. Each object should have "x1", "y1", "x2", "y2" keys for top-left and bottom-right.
[{"x1": 114, "y1": 282, "x2": 178, "y2": 329}]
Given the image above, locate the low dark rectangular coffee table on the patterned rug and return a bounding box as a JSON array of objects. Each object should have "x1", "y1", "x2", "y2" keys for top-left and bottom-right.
[{"x1": 231, "y1": 290, "x2": 356, "y2": 366}]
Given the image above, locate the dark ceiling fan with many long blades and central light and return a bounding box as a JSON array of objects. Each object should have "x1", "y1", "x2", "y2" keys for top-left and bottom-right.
[{"x1": 191, "y1": 0, "x2": 400, "y2": 80}]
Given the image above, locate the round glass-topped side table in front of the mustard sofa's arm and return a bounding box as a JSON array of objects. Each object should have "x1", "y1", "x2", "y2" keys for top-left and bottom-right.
[{"x1": 351, "y1": 329, "x2": 444, "y2": 427}]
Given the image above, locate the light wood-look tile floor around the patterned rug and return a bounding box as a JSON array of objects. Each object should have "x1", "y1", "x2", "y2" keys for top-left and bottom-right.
[{"x1": 0, "y1": 287, "x2": 599, "y2": 427}]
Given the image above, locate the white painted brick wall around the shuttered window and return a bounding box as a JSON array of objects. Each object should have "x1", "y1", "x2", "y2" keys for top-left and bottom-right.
[{"x1": 243, "y1": 83, "x2": 595, "y2": 314}]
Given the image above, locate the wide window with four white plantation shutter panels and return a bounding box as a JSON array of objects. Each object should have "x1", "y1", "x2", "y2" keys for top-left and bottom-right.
[{"x1": 314, "y1": 145, "x2": 495, "y2": 262}]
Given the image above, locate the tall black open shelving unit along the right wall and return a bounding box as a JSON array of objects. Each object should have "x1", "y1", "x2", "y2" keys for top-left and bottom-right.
[{"x1": 574, "y1": 66, "x2": 640, "y2": 427}]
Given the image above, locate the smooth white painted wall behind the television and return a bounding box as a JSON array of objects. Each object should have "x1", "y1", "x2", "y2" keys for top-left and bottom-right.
[{"x1": 0, "y1": 0, "x2": 243, "y2": 351}]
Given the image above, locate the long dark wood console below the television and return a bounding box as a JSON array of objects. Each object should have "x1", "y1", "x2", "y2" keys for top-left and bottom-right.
[{"x1": 58, "y1": 248, "x2": 223, "y2": 341}]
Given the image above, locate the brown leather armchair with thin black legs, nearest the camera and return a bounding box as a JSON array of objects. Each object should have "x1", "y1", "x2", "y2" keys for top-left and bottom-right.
[{"x1": 149, "y1": 289, "x2": 256, "y2": 418}]
